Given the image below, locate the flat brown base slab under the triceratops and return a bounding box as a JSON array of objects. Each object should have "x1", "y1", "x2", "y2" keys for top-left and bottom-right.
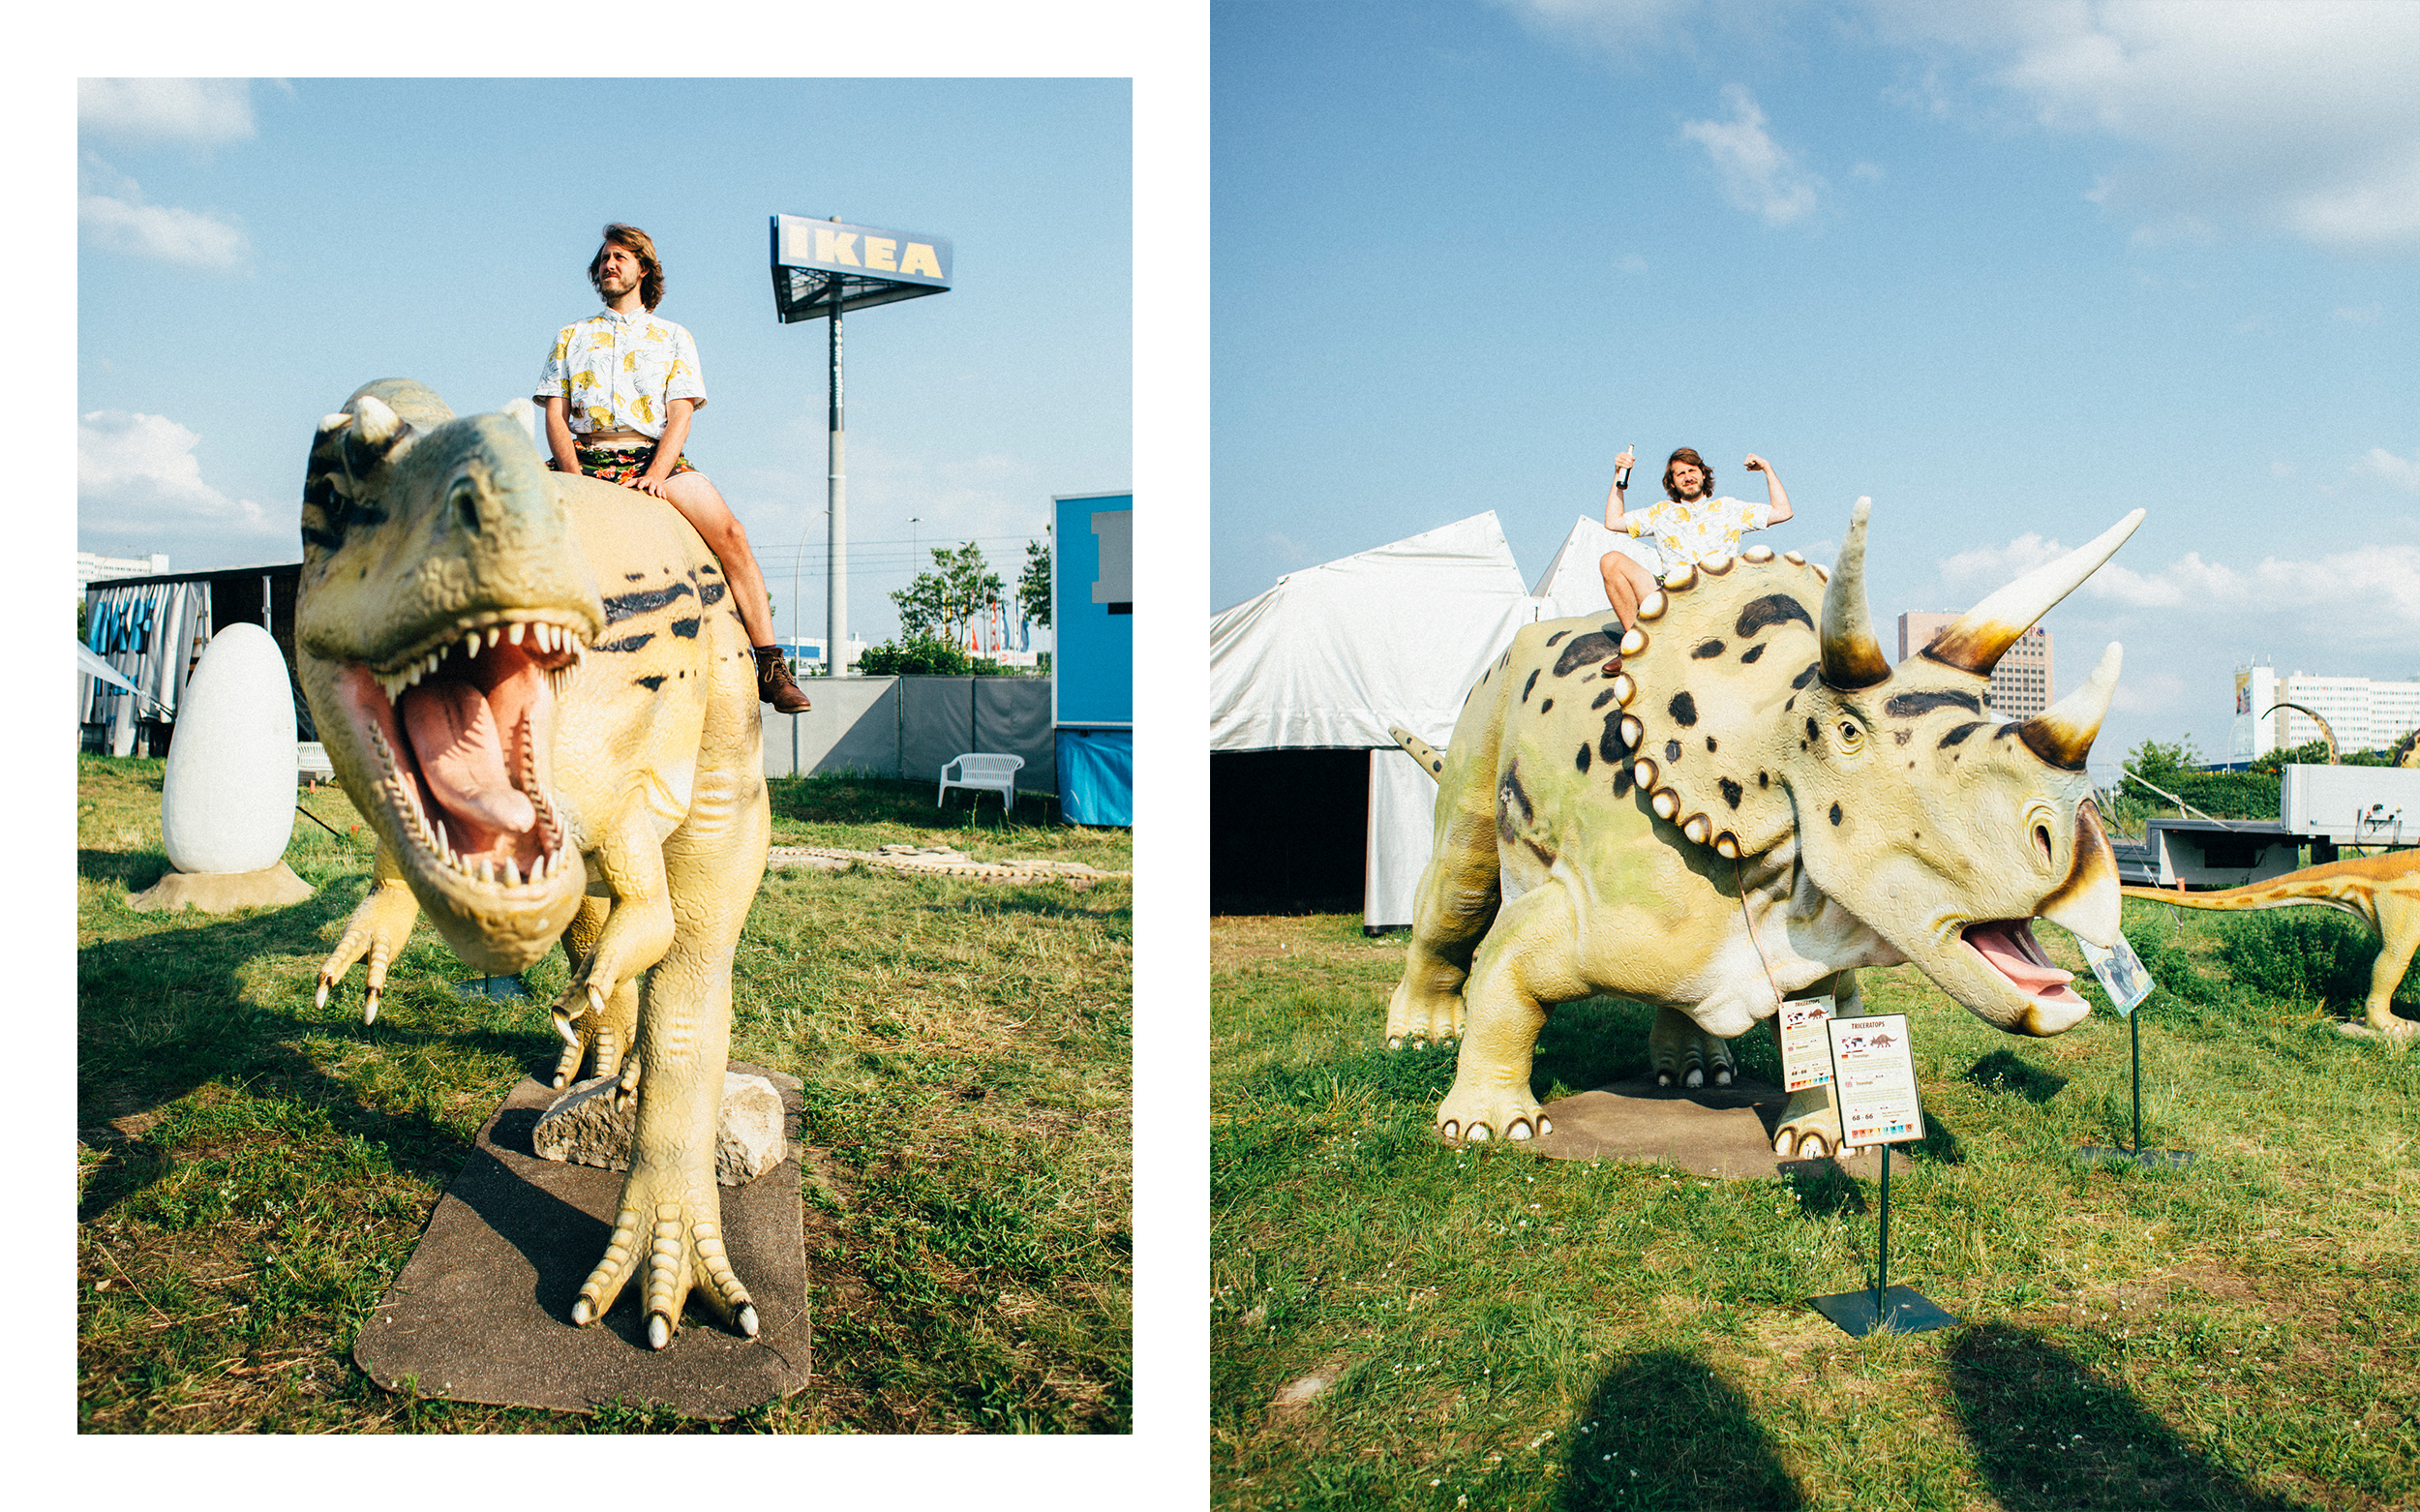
[{"x1": 1534, "y1": 1074, "x2": 1883, "y2": 1181}]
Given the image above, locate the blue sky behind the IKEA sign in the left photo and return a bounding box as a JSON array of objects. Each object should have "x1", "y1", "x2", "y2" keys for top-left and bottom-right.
[{"x1": 76, "y1": 77, "x2": 1133, "y2": 646}]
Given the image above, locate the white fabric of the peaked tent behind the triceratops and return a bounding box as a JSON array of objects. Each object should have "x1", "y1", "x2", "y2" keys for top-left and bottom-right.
[{"x1": 1210, "y1": 510, "x2": 1549, "y2": 929}]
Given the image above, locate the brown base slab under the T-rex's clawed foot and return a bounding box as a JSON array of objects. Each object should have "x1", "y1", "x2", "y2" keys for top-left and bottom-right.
[{"x1": 353, "y1": 1062, "x2": 808, "y2": 1420}]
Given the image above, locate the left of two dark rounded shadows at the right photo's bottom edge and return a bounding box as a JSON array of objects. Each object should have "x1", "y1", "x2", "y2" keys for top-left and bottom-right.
[{"x1": 1554, "y1": 1350, "x2": 1805, "y2": 1512}]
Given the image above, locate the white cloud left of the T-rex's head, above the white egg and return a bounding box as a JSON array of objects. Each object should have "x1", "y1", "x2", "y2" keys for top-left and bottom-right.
[{"x1": 76, "y1": 408, "x2": 295, "y2": 549}]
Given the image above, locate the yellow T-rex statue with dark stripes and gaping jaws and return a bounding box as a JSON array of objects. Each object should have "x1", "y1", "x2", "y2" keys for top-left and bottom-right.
[{"x1": 295, "y1": 378, "x2": 772, "y2": 1350}]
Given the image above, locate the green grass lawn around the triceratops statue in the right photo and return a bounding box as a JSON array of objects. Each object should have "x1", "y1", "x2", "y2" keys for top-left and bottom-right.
[{"x1": 1213, "y1": 902, "x2": 2420, "y2": 1512}]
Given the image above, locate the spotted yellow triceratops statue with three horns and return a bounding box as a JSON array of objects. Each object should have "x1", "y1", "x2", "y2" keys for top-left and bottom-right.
[{"x1": 1387, "y1": 499, "x2": 2142, "y2": 1157}]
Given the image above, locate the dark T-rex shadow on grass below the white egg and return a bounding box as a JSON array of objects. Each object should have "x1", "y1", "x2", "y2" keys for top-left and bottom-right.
[{"x1": 76, "y1": 888, "x2": 555, "y2": 1222}]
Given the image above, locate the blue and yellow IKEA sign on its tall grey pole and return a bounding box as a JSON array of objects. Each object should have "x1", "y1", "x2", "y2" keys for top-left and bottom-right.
[{"x1": 772, "y1": 215, "x2": 952, "y2": 678}]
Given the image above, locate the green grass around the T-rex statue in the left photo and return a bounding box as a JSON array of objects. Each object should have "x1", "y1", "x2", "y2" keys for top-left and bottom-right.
[{"x1": 77, "y1": 757, "x2": 1133, "y2": 1433}]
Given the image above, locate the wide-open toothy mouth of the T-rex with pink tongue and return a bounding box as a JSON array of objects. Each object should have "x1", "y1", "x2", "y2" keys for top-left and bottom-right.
[{"x1": 339, "y1": 612, "x2": 586, "y2": 888}]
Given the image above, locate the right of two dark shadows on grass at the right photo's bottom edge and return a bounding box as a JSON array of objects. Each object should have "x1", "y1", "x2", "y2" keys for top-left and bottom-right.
[{"x1": 1949, "y1": 1323, "x2": 2307, "y2": 1512}]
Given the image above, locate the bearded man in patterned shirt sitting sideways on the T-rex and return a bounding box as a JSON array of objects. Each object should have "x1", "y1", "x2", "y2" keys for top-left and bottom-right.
[{"x1": 532, "y1": 223, "x2": 811, "y2": 713}]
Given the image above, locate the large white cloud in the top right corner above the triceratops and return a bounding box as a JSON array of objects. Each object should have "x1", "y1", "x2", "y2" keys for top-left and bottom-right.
[{"x1": 1868, "y1": 0, "x2": 2420, "y2": 252}]
